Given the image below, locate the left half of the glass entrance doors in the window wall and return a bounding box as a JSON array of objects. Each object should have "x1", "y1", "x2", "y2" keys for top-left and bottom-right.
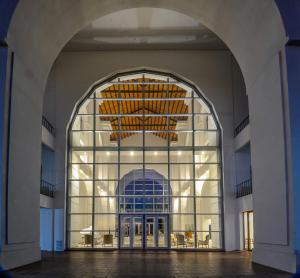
[{"x1": 120, "y1": 215, "x2": 143, "y2": 248}]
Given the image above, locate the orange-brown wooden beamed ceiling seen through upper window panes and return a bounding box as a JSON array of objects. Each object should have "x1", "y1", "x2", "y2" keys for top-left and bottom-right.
[{"x1": 98, "y1": 78, "x2": 188, "y2": 141}]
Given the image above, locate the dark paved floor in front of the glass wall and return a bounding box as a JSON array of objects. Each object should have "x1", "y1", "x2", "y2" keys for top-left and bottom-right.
[{"x1": 10, "y1": 251, "x2": 290, "y2": 278}]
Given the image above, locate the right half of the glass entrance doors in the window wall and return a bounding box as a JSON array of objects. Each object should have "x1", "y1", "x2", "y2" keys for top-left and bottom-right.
[{"x1": 145, "y1": 215, "x2": 169, "y2": 248}]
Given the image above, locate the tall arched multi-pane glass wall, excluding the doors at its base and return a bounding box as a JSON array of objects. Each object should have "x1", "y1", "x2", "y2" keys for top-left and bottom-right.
[{"x1": 67, "y1": 72, "x2": 223, "y2": 249}]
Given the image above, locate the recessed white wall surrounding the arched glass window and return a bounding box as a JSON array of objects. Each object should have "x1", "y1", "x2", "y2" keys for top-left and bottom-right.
[{"x1": 44, "y1": 51, "x2": 240, "y2": 250}]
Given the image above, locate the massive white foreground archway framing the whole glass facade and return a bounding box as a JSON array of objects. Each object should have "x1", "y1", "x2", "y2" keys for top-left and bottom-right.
[{"x1": 5, "y1": 0, "x2": 293, "y2": 269}]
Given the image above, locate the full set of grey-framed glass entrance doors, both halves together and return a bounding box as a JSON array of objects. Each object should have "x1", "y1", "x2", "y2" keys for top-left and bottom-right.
[{"x1": 120, "y1": 215, "x2": 169, "y2": 249}]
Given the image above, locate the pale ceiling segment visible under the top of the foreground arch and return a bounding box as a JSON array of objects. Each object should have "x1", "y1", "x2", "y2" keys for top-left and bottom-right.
[{"x1": 64, "y1": 8, "x2": 227, "y2": 51}]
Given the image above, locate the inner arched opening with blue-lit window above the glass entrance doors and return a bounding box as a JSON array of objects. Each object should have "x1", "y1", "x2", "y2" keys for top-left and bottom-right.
[{"x1": 116, "y1": 169, "x2": 172, "y2": 248}]
